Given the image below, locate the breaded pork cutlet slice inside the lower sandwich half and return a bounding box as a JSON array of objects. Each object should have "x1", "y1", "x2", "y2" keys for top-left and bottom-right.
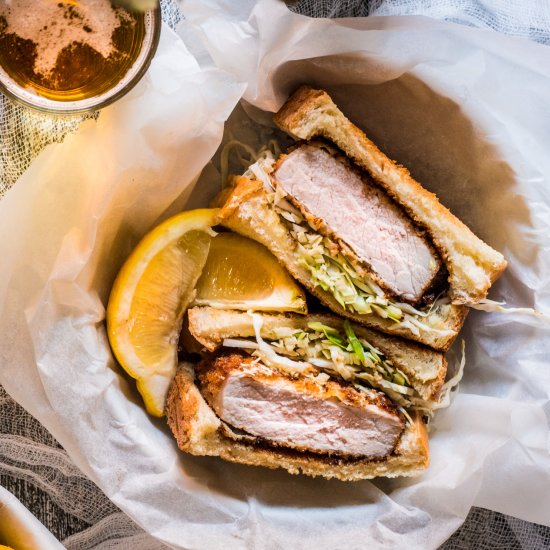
[{"x1": 197, "y1": 353, "x2": 404, "y2": 458}]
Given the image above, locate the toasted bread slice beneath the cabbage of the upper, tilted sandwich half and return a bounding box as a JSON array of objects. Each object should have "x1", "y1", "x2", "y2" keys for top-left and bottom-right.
[{"x1": 218, "y1": 176, "x2": 468, "y2": 351}]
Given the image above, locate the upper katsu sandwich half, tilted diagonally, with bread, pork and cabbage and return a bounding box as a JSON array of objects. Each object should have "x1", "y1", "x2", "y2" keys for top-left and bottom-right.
[{"x1": 215, "y1": 86, "x2": 506, "y2": 351}]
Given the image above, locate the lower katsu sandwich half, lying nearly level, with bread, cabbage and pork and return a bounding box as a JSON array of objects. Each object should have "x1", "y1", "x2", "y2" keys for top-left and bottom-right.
[{"x1": 166, "y1": 307, "x2": 461, "y2": 481}]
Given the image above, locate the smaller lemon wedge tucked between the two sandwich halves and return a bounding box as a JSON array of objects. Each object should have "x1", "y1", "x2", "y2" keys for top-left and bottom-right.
[{"x1": 193, "y1": 233, "x2": 307, "y2": 313}]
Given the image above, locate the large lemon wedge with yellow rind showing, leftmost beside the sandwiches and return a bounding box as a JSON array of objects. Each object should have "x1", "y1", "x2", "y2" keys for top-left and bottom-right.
[{"x1": 107, "y1": 209, "x2": 218, "y2": 416}]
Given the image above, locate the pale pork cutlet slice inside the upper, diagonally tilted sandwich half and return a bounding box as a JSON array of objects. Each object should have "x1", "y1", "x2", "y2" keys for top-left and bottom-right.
[{"x1": 273, "y1": 144, "x2": 441, "y2": 303}]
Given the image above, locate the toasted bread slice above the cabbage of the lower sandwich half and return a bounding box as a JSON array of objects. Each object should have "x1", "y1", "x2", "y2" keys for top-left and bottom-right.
[{"x1": 188, "y1": 307, "x2": 447, "y2": 401}]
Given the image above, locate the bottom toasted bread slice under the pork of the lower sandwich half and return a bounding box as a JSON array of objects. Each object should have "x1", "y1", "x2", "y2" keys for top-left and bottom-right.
[{"x1": 166, "y1": 364, "x2": 429, "y2": 481}]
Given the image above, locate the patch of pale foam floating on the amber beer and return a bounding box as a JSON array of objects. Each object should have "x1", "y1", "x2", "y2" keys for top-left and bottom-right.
[{"x1": 0, "y1": 0, "x2": 131, "y2": 75}]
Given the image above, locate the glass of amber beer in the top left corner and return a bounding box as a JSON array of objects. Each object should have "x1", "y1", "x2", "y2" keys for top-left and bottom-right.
[{"x1": 0, "y1": 0, "x2": 161, "y2": 113}]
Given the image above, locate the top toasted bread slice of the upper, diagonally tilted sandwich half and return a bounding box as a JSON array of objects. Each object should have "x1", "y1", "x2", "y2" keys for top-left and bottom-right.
[{"x1": 273, "y1": 86, "x2": 507, "y2": 304}]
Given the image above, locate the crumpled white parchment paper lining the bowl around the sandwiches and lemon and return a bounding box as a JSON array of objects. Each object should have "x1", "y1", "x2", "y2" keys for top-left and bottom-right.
[{"x1": 0, "y1": 0, "x2": 550, "y2": 549}]
